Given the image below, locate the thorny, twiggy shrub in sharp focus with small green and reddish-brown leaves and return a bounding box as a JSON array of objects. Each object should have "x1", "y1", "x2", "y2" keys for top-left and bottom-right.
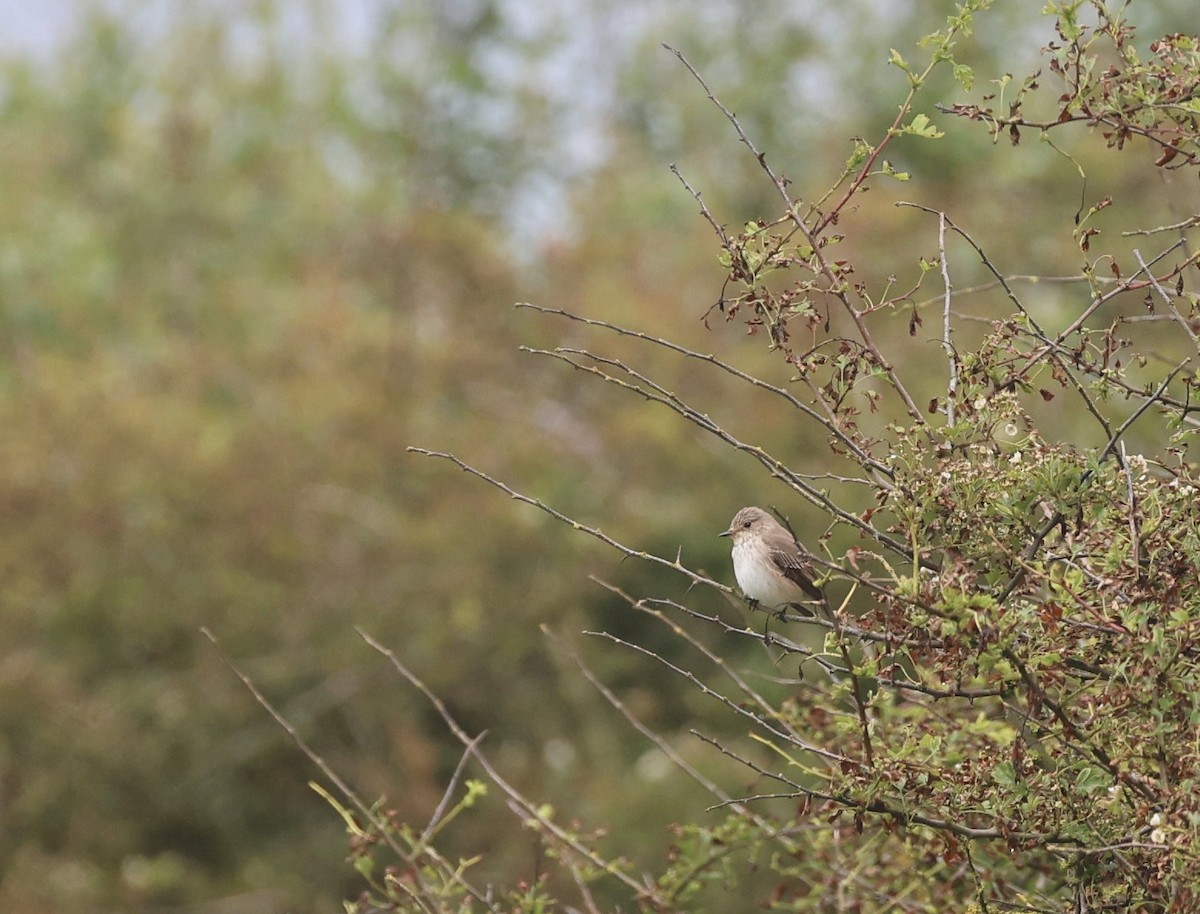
[{"x1": 231, "y1": 0, "x2": 1200, "y2": 914}]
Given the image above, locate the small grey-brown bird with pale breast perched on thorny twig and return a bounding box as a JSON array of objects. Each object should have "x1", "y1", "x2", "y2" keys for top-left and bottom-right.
[{"x1": 718, "y1": 507, "x2": 824, "y2": 611}]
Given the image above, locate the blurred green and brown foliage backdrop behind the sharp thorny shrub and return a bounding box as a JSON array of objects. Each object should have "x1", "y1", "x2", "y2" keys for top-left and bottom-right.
[{"x1": 0, "y1": 0, "x2": 1195, "y2": 914}]
